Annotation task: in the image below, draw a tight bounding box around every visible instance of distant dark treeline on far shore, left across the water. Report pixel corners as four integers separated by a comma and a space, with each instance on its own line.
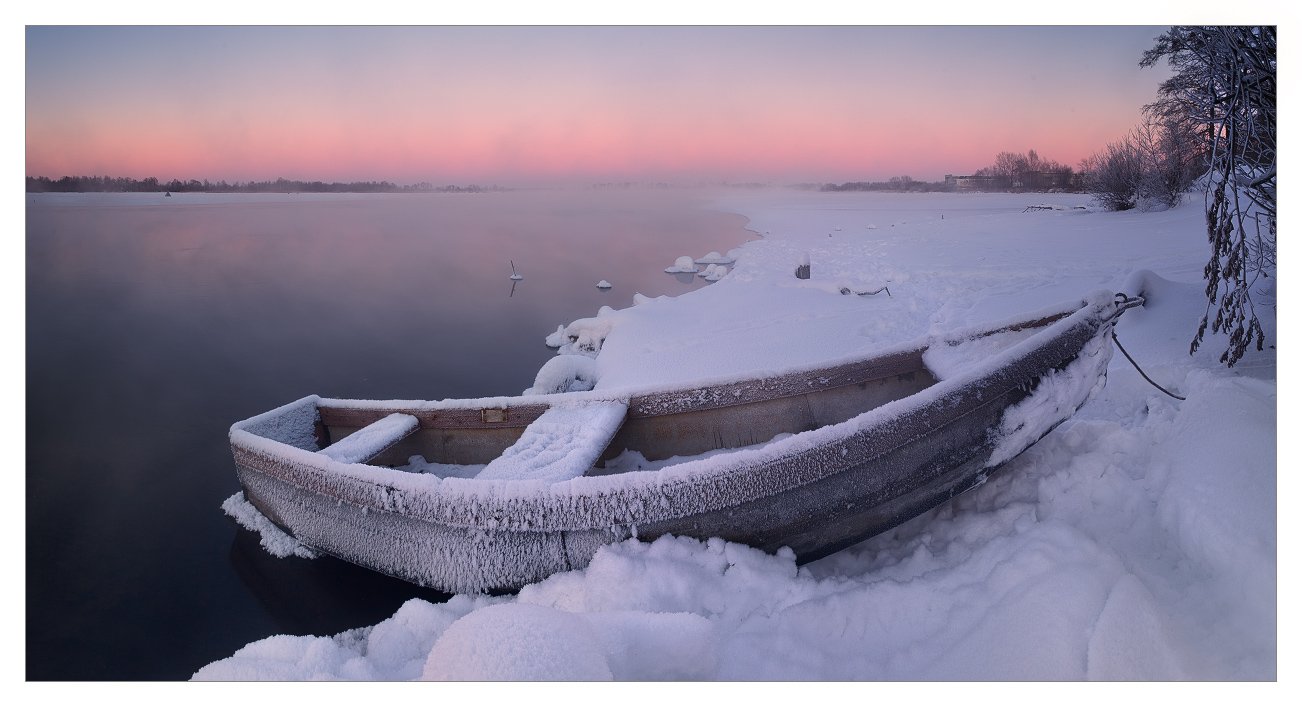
27, 177, 503, 194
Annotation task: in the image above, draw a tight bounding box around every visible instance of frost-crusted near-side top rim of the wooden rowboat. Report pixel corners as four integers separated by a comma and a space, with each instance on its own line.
226, 296, 1112, 531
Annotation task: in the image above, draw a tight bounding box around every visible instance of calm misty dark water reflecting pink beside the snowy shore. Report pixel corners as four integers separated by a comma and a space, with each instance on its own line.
26, 191, 750, 680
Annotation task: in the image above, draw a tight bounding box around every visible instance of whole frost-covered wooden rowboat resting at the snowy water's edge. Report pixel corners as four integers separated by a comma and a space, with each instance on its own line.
230, 294, 1142, 592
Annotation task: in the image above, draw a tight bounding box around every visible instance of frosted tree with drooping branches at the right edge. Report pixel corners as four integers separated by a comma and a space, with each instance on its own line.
1139, 26, 1276, 366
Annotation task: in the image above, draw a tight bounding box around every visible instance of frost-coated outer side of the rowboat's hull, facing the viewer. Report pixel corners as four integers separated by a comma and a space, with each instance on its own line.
232, 295, 1116, 592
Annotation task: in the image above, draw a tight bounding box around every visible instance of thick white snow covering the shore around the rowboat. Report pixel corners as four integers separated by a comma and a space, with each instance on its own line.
195, 191, 1277, 680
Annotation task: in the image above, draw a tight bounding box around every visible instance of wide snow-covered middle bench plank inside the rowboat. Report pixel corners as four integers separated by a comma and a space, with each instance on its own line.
476, 401, 629, 482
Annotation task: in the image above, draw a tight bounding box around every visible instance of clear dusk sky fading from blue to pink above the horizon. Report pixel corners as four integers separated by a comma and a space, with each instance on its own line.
26, 26, 1167, 184
